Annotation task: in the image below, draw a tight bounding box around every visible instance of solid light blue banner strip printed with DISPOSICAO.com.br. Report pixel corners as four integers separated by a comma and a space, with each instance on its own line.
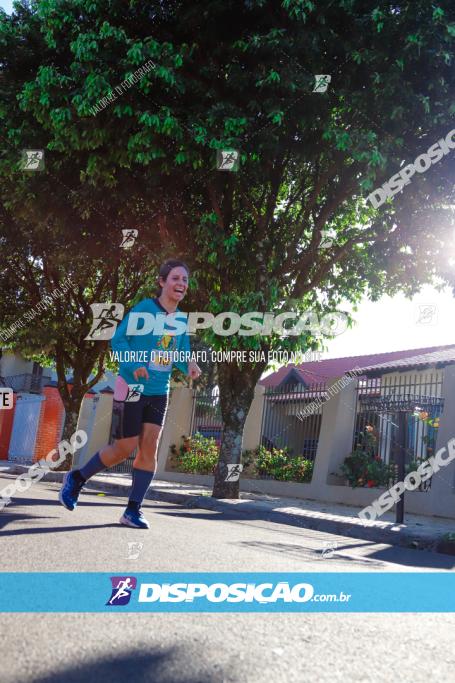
0, 572, 455, 613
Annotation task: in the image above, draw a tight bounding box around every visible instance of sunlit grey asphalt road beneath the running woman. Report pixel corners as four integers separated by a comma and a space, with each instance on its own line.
0, 474, 455, 683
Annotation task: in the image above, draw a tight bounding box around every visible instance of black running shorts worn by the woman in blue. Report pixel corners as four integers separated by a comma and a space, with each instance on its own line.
112, 394, 168, 439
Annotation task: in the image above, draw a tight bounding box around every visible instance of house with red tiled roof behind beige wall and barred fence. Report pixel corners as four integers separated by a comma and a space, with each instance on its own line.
151, 344, 455, 519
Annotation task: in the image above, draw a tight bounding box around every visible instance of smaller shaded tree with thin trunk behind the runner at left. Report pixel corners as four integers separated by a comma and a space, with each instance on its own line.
0, 4, 176, 460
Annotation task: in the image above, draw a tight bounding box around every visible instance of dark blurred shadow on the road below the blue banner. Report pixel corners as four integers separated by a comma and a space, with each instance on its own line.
28, 648, 221, 683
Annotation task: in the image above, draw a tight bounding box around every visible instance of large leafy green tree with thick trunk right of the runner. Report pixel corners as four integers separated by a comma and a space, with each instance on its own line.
2, 0, 455, 497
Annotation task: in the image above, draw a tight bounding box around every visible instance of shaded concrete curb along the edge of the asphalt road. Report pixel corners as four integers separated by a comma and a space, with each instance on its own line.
4, 465, 448, 554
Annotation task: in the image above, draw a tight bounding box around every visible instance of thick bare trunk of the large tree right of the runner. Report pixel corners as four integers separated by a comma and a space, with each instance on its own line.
212, 363, 265, 498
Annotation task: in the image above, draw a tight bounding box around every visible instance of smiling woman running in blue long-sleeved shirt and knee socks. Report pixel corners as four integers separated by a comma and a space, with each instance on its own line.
59, 260, 201, 529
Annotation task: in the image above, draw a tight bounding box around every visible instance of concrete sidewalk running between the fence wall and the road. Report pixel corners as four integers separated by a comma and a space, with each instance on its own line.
1, 465, 455, 555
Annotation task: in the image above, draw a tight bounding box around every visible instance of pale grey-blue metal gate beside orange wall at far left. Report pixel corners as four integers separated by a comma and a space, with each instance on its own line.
8, 394, 45, 463
